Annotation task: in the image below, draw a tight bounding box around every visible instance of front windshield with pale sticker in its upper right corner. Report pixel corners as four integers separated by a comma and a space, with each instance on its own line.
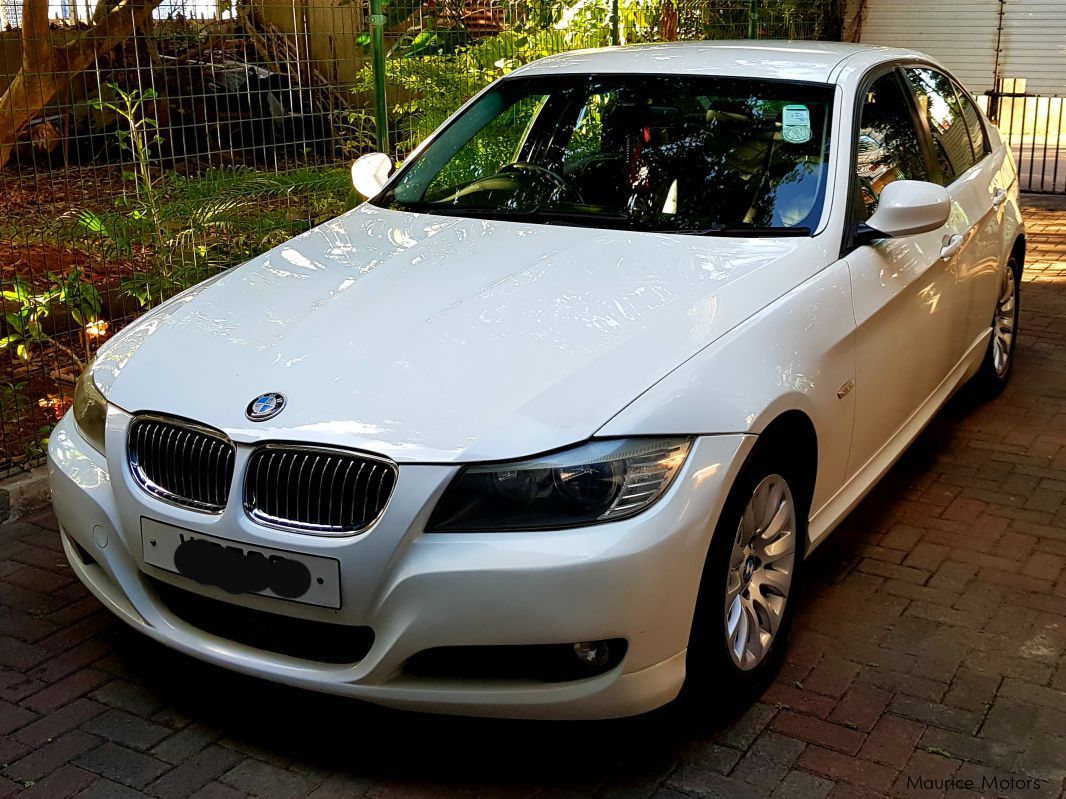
374, 75, 833, 234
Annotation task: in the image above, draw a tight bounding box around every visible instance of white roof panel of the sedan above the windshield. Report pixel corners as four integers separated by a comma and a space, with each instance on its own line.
512, 39, 930, 83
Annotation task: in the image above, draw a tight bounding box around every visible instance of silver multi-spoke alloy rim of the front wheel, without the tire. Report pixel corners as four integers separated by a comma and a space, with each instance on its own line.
725, 474, 796, 671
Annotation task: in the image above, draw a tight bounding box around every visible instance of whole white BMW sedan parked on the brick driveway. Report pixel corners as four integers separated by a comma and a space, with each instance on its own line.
49, 43, 1024, 718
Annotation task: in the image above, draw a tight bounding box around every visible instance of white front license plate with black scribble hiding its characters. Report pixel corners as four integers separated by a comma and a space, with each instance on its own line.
141, 519, 340, 607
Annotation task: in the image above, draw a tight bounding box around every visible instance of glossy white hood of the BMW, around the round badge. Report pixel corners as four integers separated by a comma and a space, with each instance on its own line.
93, 205, 822, 462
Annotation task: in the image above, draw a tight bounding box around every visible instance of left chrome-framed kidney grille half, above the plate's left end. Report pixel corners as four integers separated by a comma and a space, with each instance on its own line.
126, 413, 236, 513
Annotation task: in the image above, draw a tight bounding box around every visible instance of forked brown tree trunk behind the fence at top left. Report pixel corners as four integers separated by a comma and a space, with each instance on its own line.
0, 0, 162, 169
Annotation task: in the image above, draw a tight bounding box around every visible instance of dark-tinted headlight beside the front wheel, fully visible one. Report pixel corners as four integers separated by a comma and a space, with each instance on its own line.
426, 438, 691, 533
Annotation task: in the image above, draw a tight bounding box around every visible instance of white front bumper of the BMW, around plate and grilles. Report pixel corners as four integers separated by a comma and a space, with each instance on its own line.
49, 408, 754, 718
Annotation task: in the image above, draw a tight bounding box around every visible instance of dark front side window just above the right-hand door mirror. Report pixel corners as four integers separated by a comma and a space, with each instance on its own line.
855, 71, 928, 222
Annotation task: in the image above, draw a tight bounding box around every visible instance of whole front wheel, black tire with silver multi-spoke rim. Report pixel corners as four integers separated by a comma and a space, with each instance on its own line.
681, 442, 807, 712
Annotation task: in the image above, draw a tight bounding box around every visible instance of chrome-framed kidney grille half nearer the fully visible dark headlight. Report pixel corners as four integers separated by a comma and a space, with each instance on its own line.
244, 443, 397, 536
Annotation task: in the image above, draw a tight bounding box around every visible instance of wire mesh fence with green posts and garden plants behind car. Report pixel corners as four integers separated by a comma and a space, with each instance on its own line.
0, 0, 843, 476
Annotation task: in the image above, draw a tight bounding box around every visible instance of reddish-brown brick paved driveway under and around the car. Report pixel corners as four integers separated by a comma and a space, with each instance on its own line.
0, 199, 1066, 799
